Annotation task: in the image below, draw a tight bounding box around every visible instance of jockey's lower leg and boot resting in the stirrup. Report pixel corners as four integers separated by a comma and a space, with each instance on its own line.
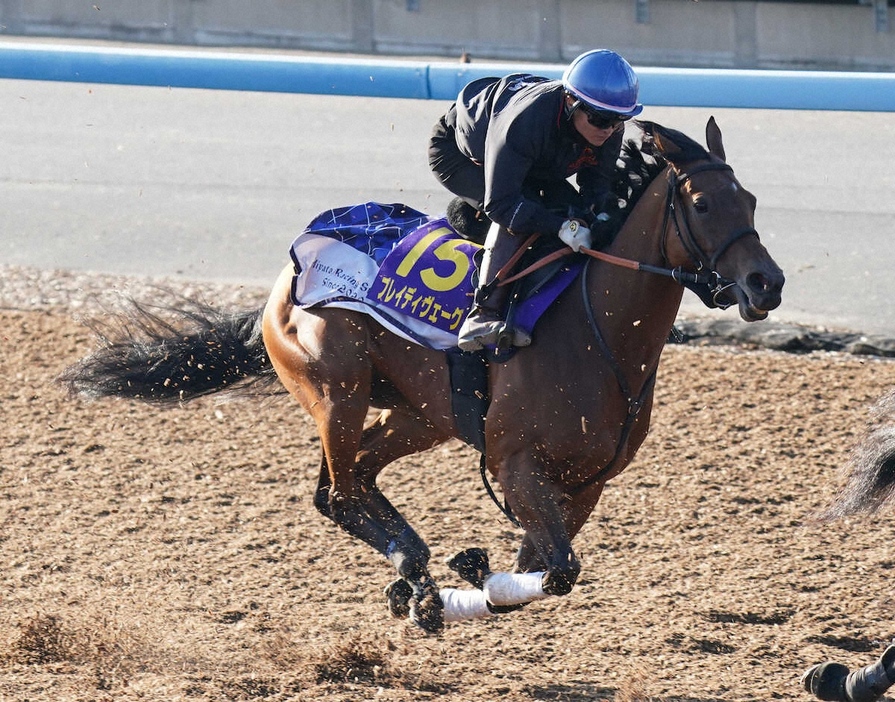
457, 224, 531, 351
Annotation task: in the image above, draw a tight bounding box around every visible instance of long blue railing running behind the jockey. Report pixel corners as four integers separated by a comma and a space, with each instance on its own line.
0, 42, 895, 112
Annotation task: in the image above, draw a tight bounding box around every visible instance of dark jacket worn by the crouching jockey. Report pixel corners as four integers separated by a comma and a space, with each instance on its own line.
445, 73, 624, 234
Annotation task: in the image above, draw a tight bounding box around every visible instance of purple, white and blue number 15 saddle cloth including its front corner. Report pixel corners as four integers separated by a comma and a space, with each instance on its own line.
290, 203, 577, 350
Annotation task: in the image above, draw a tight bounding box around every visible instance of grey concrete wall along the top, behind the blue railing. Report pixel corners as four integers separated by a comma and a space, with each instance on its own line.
0, 0, 895, 71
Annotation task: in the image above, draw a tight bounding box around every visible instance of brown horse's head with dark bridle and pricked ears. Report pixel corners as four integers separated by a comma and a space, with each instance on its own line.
640, 117, 784, 322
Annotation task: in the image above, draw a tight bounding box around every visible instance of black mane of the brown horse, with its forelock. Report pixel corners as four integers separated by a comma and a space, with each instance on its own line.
609, 120, 709, 236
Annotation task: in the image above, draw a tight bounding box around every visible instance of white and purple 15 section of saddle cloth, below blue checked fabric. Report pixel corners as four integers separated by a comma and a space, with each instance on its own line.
291, 219, 481, 350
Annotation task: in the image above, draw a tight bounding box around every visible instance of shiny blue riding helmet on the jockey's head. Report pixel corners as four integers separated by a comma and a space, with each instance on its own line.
562, 49, 643, 117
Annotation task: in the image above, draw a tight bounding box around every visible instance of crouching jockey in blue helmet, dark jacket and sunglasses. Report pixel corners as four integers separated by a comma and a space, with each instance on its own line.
429, 49, 643, 351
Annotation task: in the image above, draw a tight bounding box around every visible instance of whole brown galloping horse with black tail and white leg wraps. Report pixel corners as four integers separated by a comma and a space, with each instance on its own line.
63, 117, 784, 633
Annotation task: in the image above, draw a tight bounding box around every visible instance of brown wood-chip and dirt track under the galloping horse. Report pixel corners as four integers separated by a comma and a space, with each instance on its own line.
0, 270, 895, 702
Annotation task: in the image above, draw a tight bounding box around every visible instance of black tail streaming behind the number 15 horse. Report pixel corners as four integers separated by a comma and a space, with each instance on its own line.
59, 301, 276, 404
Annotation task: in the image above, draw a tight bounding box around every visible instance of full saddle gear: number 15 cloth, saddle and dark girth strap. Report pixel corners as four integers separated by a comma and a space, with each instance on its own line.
290, 202, 583, 451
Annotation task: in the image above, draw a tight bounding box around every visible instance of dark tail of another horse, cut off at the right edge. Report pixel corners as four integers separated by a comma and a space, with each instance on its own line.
821, 391, 895, 520
